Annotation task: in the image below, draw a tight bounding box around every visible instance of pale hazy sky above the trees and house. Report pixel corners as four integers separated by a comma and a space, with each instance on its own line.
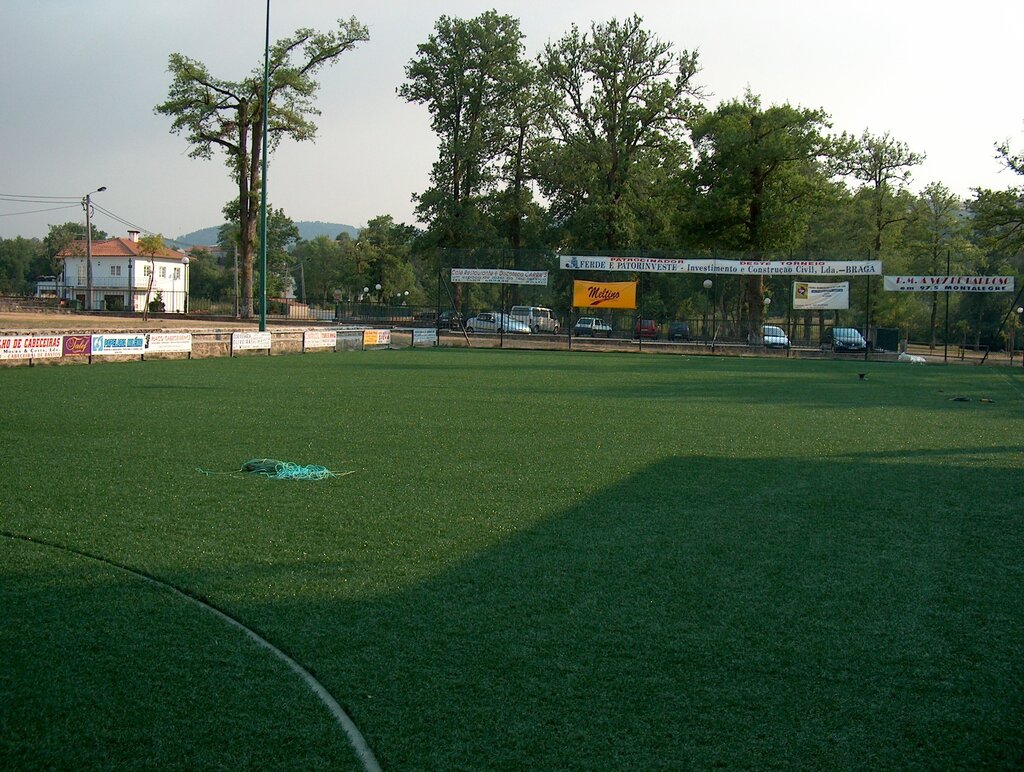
0, 0, 1024, 239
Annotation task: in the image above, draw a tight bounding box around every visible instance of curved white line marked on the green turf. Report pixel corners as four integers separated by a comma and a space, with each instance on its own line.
0, 531, 381, 772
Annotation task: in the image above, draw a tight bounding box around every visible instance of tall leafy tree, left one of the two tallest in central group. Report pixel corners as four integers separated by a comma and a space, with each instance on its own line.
398, 10, 529, 249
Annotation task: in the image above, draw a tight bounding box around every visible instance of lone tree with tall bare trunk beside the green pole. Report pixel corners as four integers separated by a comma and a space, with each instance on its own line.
156, 17, 370, 318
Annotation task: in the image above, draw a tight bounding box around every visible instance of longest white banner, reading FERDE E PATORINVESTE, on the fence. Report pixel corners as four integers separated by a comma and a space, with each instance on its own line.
558, 255, 882, 276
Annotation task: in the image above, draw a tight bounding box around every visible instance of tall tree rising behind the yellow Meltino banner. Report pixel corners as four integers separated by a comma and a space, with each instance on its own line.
536, 15, 699, 249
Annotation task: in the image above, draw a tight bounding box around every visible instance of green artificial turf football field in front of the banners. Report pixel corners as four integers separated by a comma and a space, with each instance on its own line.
0, 349, 1024, 770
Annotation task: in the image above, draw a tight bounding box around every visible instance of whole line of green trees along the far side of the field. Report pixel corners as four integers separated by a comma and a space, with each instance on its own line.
0, 11, 1024, 338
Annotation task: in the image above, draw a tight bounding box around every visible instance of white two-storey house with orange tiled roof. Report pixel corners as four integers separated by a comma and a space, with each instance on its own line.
56, 230, 188, 313
